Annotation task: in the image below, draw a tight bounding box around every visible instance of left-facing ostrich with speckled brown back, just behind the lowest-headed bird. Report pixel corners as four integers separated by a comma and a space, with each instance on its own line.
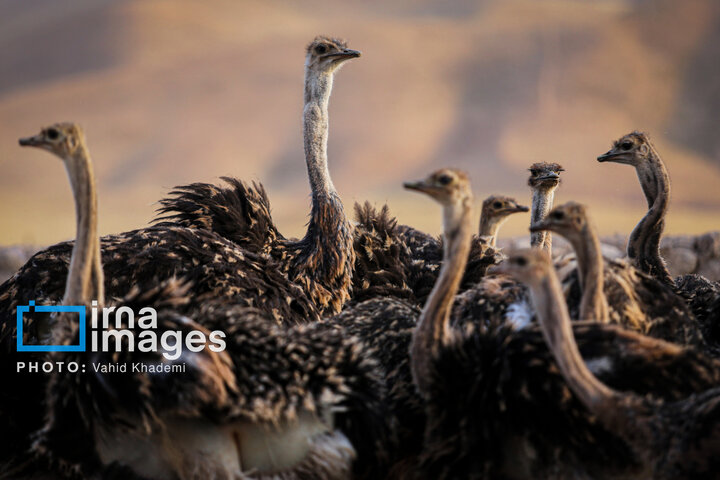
530, 202, 704, 347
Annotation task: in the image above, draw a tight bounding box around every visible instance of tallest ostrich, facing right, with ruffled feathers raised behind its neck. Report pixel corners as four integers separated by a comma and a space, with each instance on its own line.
157, 36, 360, 313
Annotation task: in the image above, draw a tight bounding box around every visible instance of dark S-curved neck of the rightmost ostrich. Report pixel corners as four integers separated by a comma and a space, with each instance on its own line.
627, 151, 675, 286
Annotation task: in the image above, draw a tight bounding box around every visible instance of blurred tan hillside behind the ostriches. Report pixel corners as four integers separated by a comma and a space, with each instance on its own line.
0, 0, 720, 244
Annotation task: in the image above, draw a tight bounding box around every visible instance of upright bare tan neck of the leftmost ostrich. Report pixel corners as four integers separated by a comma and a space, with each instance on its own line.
63, 145, 104, 305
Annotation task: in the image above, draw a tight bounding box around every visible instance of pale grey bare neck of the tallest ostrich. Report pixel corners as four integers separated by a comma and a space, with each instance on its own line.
303, 69, 336, 196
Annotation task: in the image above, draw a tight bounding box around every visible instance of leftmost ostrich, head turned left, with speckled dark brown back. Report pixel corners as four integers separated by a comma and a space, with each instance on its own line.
0, 124, 319, 478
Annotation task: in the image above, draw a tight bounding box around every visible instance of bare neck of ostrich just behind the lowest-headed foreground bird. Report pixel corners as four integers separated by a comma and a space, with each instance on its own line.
568, 222, 610, 323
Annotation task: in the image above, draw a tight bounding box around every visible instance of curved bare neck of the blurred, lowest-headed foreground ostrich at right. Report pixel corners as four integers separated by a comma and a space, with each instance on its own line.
529, 273, 615, 416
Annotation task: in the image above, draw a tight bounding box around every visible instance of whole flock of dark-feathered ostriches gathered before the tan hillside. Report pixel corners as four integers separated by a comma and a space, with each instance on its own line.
0, 37, 720, 479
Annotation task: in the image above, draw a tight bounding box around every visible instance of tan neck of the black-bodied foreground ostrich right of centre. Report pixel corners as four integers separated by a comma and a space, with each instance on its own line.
410, 195, 472, 395
